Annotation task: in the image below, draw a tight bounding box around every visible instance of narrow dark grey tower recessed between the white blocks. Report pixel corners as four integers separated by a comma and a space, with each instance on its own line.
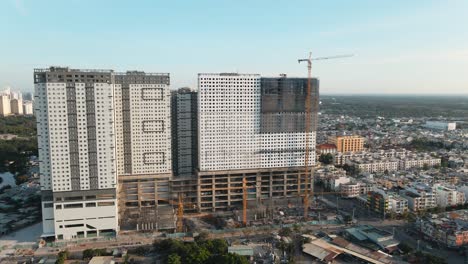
172, 88, 198, 176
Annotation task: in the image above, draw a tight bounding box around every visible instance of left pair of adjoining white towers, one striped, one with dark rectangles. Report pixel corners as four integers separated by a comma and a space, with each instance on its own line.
34, 67, 171, 239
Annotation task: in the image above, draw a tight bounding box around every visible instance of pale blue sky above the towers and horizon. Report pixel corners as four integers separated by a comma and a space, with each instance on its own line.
0, 0, 468, 94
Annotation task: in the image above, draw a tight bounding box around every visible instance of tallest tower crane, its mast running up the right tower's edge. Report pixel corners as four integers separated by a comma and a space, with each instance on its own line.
298, 52, 354, 219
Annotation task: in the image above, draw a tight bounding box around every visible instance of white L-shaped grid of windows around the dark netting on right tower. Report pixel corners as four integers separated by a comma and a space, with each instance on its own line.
198, 74, 315, 171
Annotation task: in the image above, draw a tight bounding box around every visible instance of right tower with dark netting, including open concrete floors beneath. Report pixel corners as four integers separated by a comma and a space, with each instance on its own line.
198, 73, 318, 211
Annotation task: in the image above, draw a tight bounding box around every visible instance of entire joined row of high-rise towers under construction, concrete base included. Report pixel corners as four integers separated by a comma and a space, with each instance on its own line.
34, 67, 318, 239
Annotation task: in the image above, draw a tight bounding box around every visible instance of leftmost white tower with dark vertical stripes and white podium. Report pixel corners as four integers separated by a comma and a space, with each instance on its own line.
34, 67, 118, 239
